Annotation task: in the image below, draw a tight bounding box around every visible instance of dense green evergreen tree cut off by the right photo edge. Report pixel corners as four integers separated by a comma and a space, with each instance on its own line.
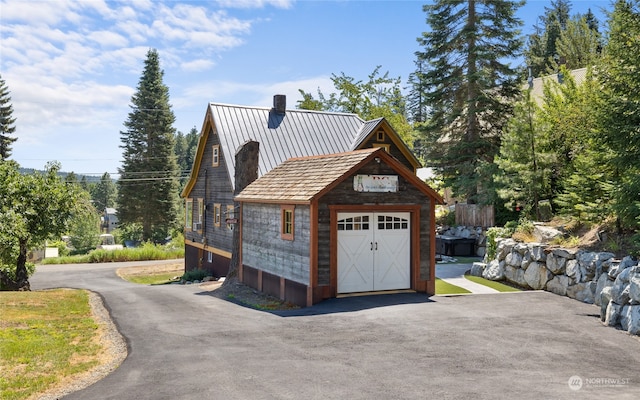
599, 0, 640, 229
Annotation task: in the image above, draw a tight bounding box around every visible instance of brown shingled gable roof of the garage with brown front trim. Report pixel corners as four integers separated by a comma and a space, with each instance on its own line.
235, 148, 443, 204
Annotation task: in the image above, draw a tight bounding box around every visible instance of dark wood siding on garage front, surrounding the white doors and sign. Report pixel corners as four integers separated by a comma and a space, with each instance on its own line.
318, 158, 431, 285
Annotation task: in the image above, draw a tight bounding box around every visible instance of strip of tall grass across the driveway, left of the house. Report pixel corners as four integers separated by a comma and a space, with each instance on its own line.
42, 243, 184, 264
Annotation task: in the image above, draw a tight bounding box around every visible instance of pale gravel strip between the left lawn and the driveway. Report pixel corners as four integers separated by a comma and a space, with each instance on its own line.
33, 291, 128, 400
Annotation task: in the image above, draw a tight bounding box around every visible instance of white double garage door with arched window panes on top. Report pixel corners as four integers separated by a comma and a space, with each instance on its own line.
338, 213, 411, 293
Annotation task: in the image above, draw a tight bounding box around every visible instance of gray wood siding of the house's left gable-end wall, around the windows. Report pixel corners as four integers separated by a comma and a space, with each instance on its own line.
185, 126, 233, 252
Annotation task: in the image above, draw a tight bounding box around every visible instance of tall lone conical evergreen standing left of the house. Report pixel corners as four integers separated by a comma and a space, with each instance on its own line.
118, 49, 178, 241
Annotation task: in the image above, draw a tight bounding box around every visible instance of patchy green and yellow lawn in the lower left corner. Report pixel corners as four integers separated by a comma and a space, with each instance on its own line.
0, 289, 102, 400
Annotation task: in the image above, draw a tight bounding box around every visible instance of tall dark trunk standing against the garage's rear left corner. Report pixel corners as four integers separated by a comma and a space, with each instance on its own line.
223, 141, 260, 286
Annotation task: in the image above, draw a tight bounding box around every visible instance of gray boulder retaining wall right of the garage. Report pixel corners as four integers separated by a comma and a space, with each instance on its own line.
471, 239, 640, 335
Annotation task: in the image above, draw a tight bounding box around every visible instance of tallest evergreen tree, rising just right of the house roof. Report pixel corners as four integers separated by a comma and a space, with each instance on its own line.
417, 0, 523, 203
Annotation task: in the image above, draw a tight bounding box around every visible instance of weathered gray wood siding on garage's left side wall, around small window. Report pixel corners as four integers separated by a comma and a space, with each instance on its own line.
242, 203, 310, 285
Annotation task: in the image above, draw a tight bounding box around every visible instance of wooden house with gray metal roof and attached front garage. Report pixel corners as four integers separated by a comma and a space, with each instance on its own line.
182, 95, 442, 305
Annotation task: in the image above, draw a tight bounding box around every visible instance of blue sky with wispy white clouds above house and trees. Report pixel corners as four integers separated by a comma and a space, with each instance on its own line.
0, 0, 612, 176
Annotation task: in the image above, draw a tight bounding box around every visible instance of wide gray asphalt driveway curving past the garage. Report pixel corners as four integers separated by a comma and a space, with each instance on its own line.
31, 263, 640, 400
